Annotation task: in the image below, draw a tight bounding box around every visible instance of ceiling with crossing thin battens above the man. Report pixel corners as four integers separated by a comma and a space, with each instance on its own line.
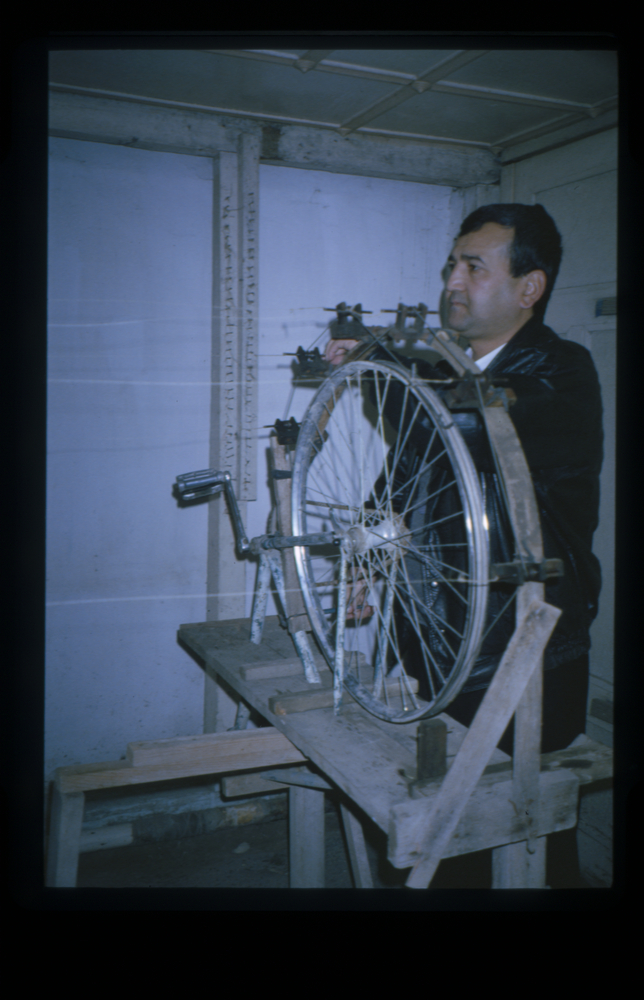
50, 49, 617, 154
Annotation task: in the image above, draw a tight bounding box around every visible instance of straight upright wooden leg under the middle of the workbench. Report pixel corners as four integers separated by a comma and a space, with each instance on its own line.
288, 785, 324, 889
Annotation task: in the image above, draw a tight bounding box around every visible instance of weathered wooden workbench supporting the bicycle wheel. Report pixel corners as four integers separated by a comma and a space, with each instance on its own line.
179, 617, 612, 884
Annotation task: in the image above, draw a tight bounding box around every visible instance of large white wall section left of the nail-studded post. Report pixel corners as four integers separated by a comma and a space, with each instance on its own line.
45, 139, 212, 778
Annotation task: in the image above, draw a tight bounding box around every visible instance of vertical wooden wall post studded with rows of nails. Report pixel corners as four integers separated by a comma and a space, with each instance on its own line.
204, 133, 259, 732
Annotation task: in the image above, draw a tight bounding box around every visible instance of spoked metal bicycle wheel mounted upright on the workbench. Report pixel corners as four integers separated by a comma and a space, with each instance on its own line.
292, 361, 488, 722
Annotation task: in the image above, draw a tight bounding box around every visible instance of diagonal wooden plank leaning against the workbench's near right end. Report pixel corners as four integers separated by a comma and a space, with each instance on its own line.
406, 601, 561, 889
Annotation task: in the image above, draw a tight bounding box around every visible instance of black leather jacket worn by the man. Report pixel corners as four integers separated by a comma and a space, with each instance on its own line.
378, 317, 603, 691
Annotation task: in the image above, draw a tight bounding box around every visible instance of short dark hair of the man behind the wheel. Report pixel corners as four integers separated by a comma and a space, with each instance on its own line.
458, 204, 561, 320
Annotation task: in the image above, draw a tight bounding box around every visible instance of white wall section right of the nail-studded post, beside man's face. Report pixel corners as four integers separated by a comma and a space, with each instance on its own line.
247, 165, 452, 614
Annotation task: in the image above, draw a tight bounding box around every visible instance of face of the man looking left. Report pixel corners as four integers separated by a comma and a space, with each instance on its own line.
445, 222, 532, 340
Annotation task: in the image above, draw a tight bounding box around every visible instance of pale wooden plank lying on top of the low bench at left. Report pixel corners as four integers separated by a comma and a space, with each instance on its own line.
127, 727, 304, 773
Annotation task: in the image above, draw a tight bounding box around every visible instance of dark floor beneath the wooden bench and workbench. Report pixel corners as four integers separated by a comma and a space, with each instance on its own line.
77, 796, 589, 889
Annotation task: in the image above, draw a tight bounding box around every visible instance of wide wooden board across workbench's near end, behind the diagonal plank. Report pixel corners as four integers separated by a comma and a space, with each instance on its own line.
388, 766, 579, 868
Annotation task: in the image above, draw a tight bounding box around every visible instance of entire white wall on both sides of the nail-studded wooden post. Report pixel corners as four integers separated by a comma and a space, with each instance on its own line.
46, 145, 460, 778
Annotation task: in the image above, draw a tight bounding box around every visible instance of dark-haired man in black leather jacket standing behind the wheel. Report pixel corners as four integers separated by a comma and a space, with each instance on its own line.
326, 204, 603, 753
